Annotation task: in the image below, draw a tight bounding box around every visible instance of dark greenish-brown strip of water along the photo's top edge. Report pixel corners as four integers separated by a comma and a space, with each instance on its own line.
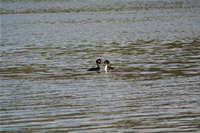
1, 0, 199, 14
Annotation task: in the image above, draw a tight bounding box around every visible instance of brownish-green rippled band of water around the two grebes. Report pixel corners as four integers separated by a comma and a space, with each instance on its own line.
1, 41, 200, 80
